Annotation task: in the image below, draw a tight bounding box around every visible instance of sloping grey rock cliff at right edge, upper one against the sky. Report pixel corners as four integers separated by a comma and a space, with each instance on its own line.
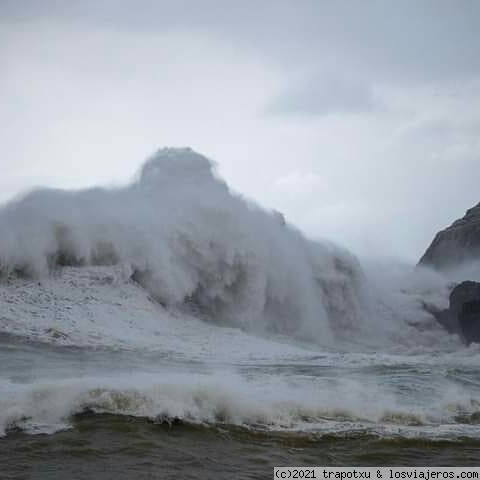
419, 203, 480, 270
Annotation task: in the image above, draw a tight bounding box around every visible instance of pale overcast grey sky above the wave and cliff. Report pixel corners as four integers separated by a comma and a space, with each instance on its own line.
0, 0, 480, 260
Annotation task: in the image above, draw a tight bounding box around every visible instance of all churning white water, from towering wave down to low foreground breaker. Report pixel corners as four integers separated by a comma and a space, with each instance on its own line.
0, 148, 480, 476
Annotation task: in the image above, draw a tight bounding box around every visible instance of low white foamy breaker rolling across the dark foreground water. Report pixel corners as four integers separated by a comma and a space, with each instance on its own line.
0, 372, 480, 436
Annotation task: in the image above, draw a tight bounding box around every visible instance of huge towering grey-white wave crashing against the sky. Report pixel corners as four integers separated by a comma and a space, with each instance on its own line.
0, 148, 464, 344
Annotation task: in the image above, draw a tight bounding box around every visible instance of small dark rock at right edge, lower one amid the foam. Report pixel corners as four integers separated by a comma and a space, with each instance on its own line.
429, 281, 480, 345
